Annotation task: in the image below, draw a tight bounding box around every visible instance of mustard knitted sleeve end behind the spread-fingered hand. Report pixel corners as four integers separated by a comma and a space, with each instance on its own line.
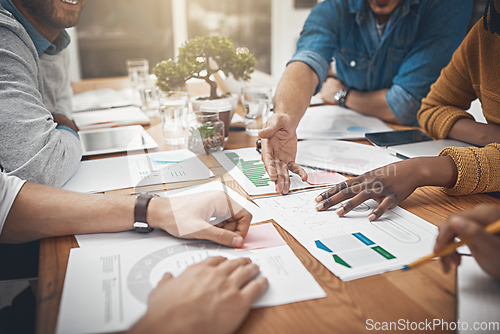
439, 144, 500, 196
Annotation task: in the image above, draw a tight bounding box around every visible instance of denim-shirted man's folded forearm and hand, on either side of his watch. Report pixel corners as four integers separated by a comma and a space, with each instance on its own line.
318, 77, 399, 124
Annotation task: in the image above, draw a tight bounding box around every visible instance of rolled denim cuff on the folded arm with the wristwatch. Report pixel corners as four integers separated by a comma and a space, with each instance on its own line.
385, 85, 420, 126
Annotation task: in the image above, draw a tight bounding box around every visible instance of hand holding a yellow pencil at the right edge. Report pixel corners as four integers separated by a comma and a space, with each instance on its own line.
434, 205, 500, 280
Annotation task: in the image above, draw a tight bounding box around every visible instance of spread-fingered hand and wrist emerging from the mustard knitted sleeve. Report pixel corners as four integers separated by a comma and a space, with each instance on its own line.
316, 156, 457, 220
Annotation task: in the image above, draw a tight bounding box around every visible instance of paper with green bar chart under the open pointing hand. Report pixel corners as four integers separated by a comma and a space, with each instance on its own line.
212, 148, 320, 196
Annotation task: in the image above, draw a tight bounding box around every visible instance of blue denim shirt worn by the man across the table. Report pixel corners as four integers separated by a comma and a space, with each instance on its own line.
290, 0, 472, 125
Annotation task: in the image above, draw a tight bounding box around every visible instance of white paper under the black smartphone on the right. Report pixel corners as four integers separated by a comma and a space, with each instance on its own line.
387, 139, 473, 159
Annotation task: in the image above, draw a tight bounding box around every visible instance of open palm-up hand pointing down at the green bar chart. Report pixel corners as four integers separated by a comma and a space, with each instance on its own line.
259, 114, 307, 194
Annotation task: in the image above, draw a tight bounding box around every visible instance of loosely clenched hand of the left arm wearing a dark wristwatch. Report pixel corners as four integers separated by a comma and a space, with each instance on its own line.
147, 191, 252, 247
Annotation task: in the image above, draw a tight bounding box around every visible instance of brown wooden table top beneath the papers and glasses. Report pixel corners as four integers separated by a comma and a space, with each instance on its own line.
36, 78, 500, 333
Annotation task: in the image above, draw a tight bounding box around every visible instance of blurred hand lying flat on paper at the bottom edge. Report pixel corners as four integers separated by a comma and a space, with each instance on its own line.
130, 257, 268, 334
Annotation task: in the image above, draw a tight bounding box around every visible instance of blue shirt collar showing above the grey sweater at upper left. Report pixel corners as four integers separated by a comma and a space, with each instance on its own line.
0, 0, 71, 55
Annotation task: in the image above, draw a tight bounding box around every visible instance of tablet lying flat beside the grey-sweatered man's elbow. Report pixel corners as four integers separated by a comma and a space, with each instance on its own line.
78, 125, 158, 156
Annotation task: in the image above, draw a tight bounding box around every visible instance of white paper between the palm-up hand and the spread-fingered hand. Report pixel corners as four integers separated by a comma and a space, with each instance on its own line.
295, 140, 401, 175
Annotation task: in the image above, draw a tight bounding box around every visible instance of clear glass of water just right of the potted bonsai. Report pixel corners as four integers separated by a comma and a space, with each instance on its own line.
241, 87, 273, 136
